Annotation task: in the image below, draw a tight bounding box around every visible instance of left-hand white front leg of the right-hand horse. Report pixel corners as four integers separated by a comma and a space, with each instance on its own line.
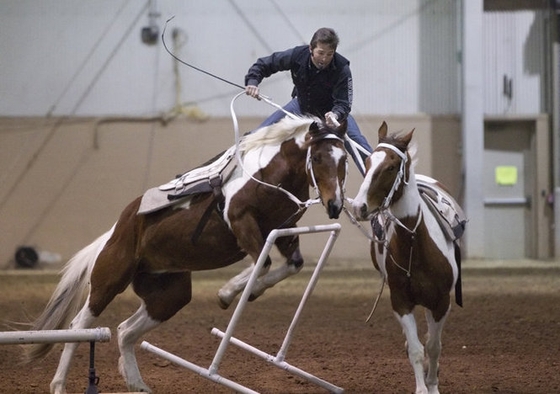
395, 311, 428, 394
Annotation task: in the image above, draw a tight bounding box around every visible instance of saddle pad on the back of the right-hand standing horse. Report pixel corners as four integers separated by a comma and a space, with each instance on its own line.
416, 175, 467, 241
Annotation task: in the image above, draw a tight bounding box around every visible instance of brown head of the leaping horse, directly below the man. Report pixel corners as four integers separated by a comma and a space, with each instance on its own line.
306, 121, 348, 219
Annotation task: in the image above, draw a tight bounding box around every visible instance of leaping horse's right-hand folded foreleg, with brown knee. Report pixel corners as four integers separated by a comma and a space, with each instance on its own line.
249, 236, 303, 301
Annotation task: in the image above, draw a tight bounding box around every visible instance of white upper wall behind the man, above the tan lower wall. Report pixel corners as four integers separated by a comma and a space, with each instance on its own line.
0, 0, 459, 116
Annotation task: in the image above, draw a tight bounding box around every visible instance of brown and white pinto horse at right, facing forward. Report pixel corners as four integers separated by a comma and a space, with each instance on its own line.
352, 122, 464, 394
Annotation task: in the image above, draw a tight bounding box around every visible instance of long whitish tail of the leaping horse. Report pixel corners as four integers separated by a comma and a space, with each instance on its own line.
25, 227, 114, 362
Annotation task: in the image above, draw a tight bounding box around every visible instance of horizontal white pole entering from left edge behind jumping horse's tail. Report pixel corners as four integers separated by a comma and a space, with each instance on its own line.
0, 327, 111, 345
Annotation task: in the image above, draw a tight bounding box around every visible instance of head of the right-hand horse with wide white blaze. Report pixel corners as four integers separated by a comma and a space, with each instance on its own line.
352, 122, 414, 220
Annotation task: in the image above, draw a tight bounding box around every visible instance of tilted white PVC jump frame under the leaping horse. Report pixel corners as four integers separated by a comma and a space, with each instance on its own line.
140, 223, 344, 394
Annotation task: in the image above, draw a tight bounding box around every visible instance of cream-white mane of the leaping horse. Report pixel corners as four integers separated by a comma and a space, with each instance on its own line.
239, 116, 316, 152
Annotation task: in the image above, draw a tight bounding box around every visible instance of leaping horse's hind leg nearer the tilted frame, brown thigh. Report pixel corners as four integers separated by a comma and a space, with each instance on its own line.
118, 272, 192, 393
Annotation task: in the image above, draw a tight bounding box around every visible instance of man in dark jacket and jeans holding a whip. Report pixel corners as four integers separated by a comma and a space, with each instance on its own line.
245, 27, 372, 175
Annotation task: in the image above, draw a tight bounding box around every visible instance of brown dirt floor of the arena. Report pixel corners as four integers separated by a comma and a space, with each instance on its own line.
0, 261, 560, 394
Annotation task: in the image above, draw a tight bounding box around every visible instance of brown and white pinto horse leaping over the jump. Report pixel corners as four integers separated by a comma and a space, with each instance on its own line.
27, 117, 347, 394
